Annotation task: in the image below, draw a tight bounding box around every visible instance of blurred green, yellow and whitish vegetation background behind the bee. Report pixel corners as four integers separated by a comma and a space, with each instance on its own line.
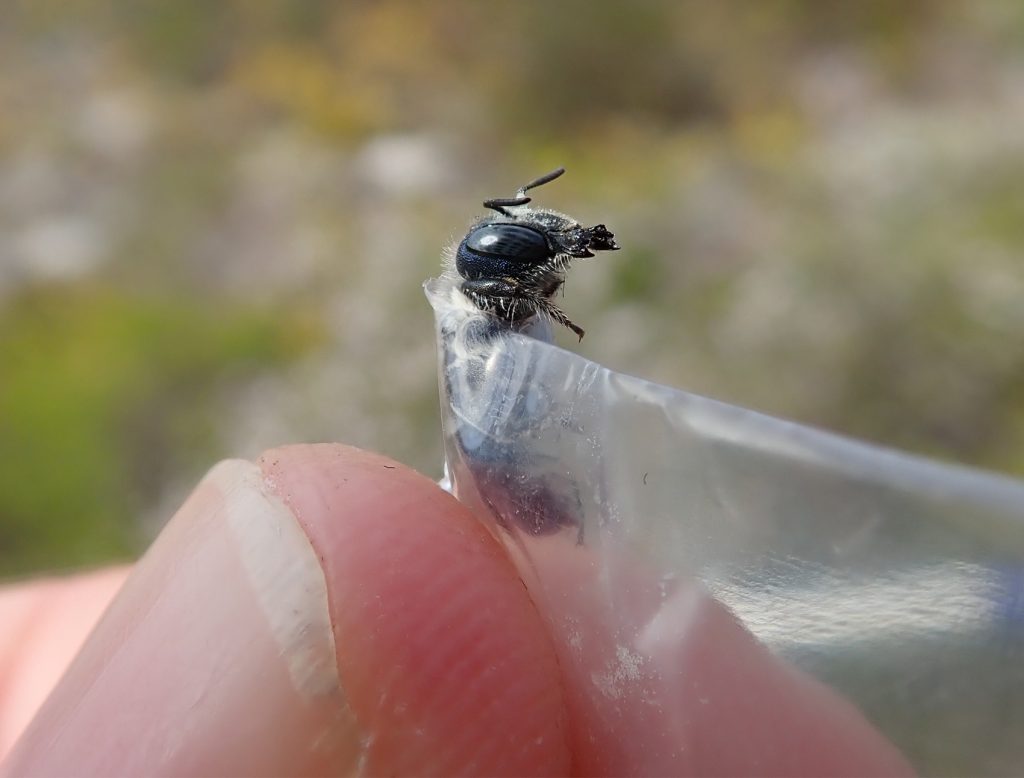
0, 0, 1024, 577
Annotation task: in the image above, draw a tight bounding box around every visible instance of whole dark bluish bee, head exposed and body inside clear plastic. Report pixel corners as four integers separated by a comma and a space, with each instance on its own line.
435, 168, 618, 543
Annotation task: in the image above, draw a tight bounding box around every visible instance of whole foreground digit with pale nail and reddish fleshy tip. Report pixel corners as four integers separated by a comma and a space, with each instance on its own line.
5, 446, 568, 775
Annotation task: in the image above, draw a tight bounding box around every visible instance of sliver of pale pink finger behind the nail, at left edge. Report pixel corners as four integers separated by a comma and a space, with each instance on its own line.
0, 567, 128, 759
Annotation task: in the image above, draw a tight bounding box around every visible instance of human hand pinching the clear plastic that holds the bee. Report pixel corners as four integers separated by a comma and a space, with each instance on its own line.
0, 445, 909, 775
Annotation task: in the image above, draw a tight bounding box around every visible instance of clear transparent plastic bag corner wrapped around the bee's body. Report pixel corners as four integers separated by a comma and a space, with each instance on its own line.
427, 280, 1024, 775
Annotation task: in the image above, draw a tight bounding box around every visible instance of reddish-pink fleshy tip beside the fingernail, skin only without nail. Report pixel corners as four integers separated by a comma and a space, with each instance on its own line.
259, 445, 569, 775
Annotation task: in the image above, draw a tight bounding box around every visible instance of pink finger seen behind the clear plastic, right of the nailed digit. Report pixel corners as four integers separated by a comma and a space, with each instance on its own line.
521, 537, 912, 776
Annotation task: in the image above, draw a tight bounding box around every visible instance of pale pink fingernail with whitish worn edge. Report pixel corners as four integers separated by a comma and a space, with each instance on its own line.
6, 461, 359, 775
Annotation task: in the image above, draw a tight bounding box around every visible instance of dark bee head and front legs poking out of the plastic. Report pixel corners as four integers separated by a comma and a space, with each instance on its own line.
455, 168, 620, 340
